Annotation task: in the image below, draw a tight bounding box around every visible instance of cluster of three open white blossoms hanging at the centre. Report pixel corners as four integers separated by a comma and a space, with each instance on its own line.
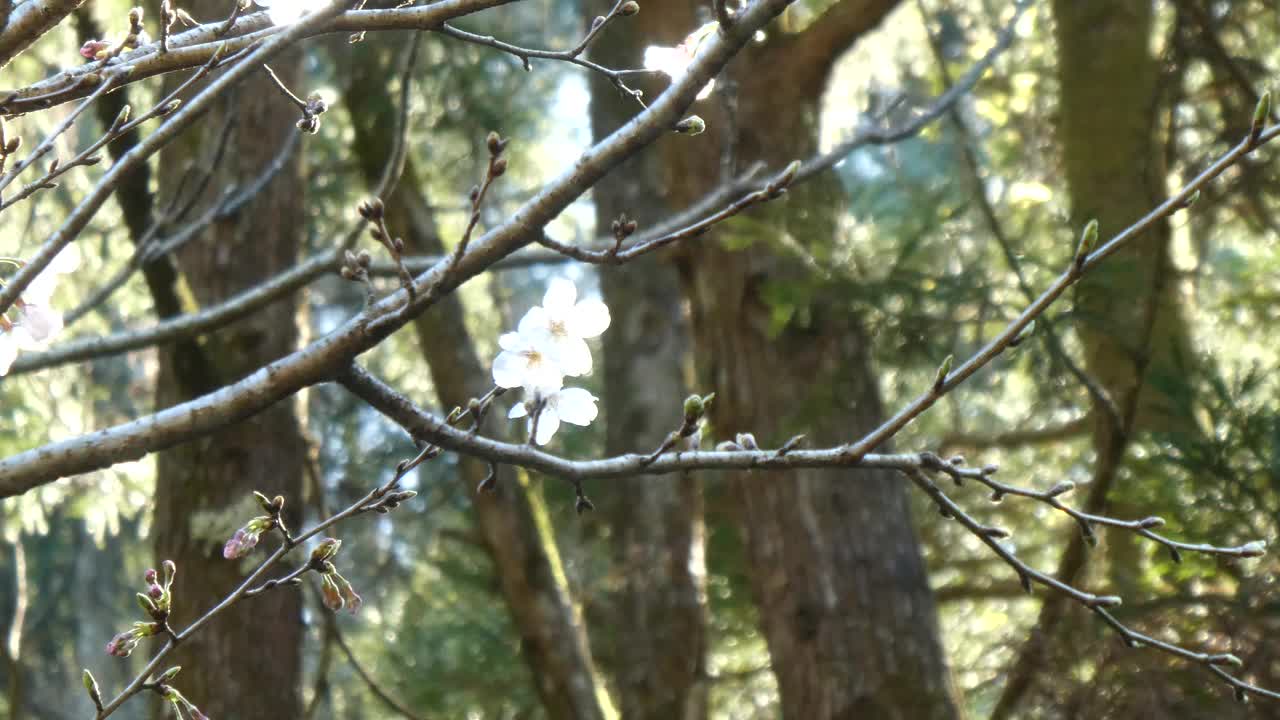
493, 278, 609, 445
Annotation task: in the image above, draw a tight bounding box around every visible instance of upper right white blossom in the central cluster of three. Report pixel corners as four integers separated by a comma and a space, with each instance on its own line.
518, 278, 609, 376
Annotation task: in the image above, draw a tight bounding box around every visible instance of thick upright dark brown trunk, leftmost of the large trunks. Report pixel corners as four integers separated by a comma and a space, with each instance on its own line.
155, 19, 306, 717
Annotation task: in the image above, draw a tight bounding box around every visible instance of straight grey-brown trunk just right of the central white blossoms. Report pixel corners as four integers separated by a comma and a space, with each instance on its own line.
588, 11, 708, 720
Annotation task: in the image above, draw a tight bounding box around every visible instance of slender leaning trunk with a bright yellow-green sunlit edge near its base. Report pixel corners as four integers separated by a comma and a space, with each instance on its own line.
344, 40, 613, 720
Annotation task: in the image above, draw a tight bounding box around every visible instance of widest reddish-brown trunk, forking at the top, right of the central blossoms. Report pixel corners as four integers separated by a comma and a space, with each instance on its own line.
637, 0, 959, 719
